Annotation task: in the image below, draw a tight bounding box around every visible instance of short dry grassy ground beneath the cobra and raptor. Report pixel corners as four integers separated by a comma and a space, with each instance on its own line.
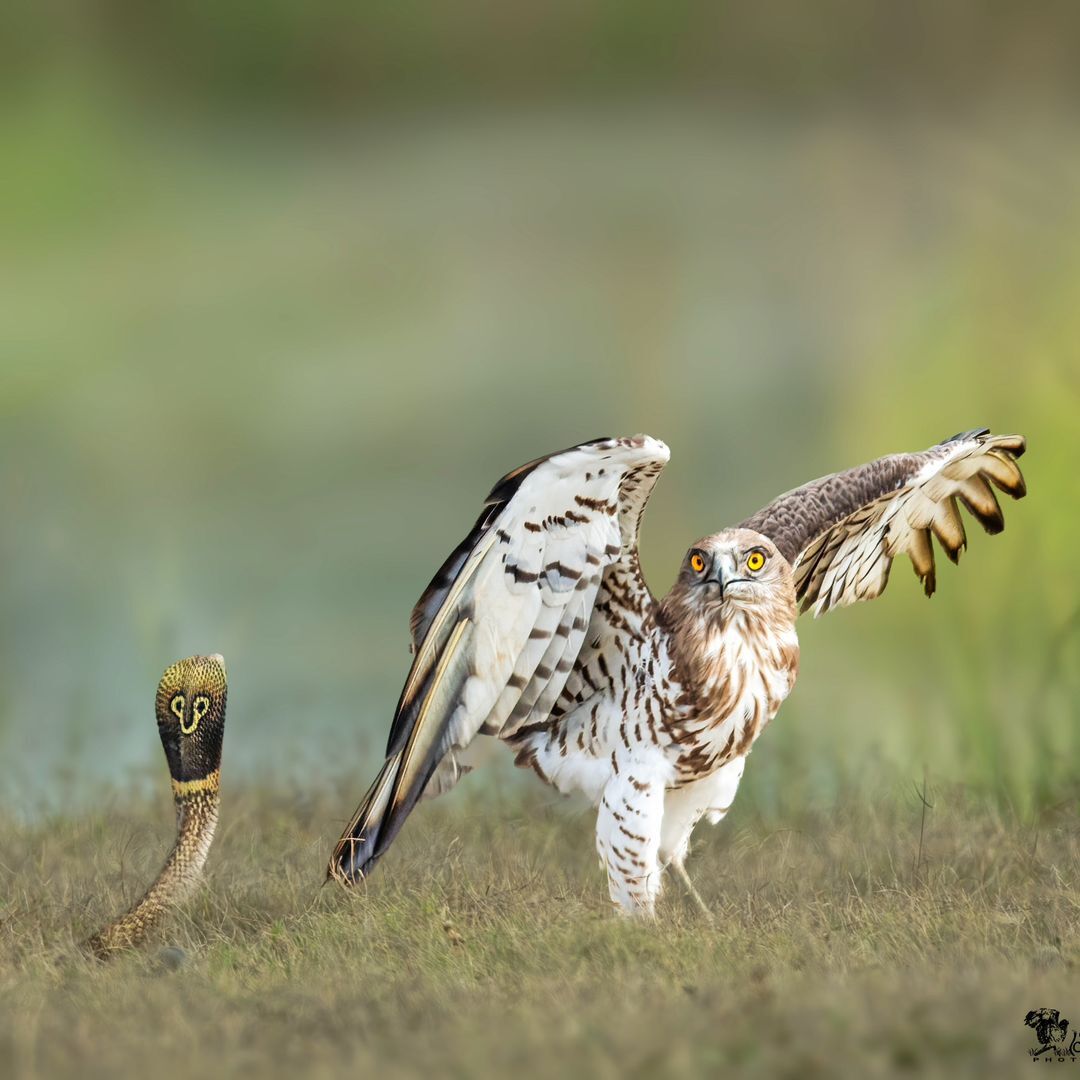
0, 789, 1080, 1077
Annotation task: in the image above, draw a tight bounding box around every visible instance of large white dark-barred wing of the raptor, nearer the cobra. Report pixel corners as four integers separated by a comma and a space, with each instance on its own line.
329, 435, 669, 880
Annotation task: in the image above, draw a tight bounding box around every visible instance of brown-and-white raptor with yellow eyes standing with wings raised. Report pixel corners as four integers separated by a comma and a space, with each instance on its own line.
328, 429, 1025, 916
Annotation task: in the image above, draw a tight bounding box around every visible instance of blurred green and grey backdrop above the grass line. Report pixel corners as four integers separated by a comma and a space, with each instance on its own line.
0, 0, 1080, 816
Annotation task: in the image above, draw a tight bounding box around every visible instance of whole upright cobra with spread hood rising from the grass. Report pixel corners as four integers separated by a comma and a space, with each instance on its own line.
86, 656, 228, 958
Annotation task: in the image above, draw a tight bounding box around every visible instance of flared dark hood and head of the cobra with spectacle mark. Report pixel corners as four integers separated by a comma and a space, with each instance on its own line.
154, 654, 228, 793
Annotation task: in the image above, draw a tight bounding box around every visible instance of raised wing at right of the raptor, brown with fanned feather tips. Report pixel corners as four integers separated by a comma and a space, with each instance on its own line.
742, 429, 1026, 616
